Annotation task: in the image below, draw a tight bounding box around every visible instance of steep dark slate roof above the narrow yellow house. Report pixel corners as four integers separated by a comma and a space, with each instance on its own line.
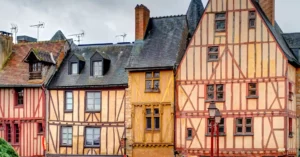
127, 15, 188, 69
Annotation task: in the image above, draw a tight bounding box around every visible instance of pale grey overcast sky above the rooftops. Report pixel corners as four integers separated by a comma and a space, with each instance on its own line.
0, 0, 300, 43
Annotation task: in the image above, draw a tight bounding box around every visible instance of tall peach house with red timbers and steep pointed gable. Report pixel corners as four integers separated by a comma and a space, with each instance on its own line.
175, 0, 299, 157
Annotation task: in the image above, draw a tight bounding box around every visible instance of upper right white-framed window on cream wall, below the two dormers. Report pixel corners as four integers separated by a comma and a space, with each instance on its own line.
86, 92, 101, 111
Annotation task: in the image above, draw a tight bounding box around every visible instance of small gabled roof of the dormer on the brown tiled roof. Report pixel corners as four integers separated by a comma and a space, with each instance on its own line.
24, 48, 56, 64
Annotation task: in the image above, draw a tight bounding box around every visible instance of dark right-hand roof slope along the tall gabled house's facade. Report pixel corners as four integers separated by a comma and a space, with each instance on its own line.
252, 0, 300, 66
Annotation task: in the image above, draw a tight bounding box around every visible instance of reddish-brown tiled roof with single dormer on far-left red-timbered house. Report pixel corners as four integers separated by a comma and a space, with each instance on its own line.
0, 41, 66, 87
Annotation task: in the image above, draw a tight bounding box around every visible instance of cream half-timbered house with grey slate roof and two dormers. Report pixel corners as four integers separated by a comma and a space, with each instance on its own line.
47, 43, 132, 157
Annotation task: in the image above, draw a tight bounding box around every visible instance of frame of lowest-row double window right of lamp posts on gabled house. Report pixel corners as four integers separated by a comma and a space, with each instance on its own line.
235, 117, 254, 136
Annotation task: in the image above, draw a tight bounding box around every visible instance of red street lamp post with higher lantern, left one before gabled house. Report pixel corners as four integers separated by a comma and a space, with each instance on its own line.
208, 102, 217, 157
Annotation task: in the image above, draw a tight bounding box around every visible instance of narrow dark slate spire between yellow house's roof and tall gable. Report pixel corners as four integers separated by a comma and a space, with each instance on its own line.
186, 0, 204, 35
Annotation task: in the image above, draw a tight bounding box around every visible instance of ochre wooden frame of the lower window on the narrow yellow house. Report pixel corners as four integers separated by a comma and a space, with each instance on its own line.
144, 107, 162, 131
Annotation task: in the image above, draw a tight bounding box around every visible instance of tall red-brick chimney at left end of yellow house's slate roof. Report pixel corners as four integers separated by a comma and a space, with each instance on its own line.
135, 4, 150, 40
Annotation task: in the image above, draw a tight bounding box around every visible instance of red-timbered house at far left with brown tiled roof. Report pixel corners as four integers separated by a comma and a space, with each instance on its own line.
0, 32, 69, 157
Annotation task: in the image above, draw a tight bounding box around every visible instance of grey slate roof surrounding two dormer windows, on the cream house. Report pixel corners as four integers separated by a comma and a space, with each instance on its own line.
48, 44, 133, 89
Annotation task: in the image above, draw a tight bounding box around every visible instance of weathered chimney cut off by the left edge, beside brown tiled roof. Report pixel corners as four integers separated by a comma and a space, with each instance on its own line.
0, 31, 13, 69
